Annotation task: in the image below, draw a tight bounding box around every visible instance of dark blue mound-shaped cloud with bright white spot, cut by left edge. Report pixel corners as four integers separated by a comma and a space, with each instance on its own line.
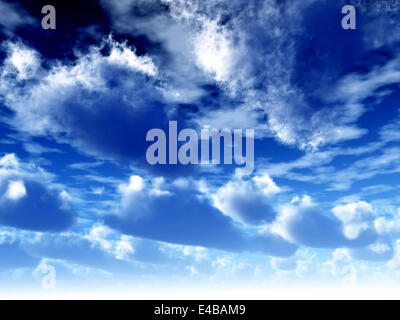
0, 154, 75, 232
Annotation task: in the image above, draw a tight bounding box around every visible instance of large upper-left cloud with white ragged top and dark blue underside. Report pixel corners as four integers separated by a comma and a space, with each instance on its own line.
0, 38, 185, 172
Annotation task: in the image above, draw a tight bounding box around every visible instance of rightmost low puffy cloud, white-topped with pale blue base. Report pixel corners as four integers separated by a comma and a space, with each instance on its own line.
267, 196, 377, 248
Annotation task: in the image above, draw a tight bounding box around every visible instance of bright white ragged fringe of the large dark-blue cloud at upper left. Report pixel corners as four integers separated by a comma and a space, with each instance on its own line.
0, 37, 158, 136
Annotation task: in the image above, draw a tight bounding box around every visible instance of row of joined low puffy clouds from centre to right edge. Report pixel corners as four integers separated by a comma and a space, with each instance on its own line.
105, 171, 400, 262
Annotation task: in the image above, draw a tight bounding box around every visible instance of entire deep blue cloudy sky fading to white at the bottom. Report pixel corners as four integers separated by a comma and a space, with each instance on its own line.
0, 0, 400, 294
